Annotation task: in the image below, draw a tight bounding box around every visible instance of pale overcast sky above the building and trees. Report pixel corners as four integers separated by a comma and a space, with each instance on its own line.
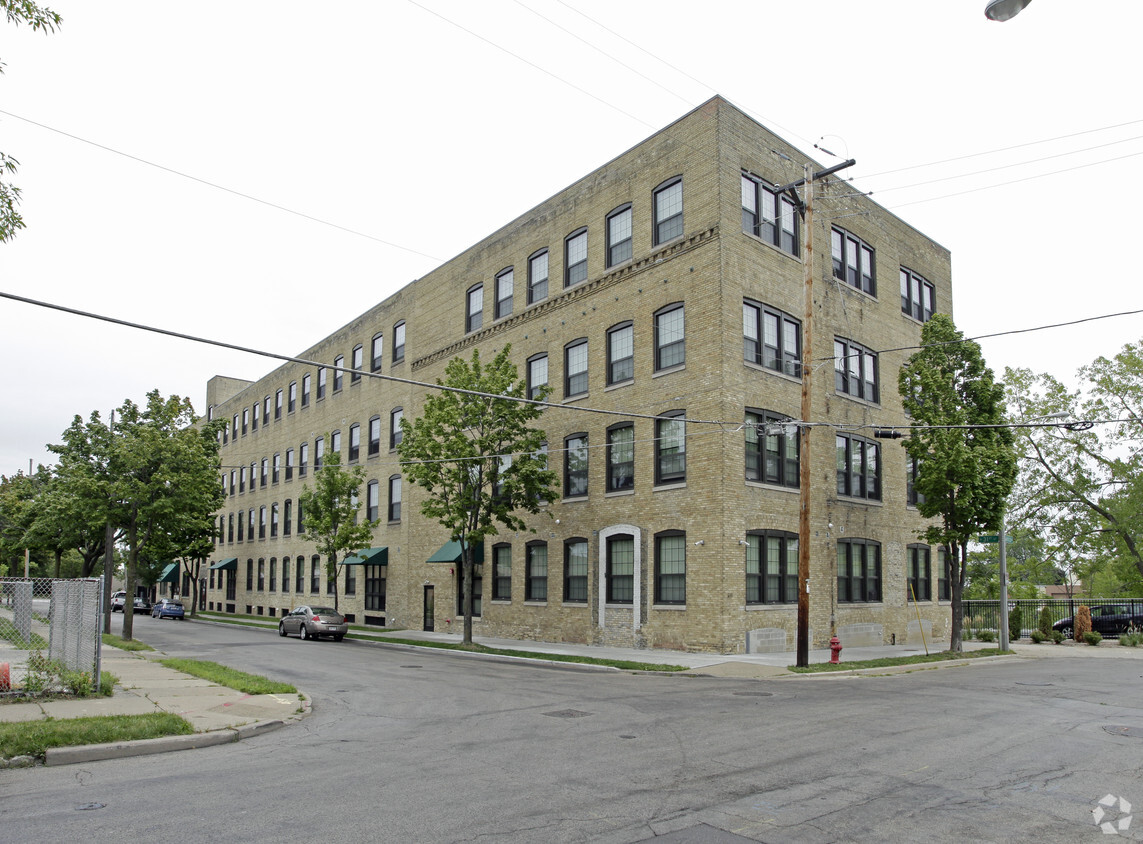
0, 0, 1143, 475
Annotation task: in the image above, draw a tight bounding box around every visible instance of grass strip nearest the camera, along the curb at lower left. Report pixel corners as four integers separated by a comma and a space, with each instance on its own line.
0, 712, 194, 758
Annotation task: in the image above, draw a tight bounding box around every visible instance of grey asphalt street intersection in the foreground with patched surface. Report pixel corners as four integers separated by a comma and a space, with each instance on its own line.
0, 618, 1143, 844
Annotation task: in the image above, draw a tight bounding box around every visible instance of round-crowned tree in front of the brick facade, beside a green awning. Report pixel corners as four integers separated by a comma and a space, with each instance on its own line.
398, 345, 557, 644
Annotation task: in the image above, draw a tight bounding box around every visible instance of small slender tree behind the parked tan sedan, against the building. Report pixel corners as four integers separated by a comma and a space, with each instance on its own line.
297, 448, 377, 610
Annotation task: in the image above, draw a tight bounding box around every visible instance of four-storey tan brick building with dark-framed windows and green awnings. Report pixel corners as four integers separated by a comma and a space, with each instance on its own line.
207, 97, 952, 653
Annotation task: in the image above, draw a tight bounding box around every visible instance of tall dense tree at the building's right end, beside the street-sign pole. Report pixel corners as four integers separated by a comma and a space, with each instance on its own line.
898, 313, 1016, 651
